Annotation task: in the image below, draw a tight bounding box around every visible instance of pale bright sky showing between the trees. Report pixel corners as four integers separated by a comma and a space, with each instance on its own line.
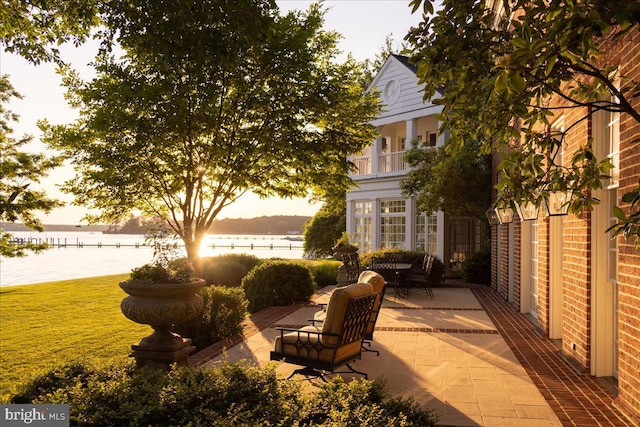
0, 0, 420, 224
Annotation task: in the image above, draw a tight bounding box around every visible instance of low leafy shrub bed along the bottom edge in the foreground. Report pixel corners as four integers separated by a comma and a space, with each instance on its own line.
13, 364, 438, 427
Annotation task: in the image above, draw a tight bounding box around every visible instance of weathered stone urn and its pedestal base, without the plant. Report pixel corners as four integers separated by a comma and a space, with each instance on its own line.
120, 279, 205, 370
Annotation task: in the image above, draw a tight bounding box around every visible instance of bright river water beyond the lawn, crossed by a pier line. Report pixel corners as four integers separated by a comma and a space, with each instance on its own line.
0, 232, 303, 286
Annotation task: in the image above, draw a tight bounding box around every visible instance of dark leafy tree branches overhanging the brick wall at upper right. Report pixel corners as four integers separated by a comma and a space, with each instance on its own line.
407, 0, 640, 244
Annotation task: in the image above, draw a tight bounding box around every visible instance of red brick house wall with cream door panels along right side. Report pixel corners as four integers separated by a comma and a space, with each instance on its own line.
489, 1, 640, 421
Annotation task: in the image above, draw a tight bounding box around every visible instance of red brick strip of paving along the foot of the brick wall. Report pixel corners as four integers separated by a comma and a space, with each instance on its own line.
472, 288, 636, 427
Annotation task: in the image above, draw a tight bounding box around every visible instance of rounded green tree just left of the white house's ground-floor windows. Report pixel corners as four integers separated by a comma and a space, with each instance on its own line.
304, 197, 347, 258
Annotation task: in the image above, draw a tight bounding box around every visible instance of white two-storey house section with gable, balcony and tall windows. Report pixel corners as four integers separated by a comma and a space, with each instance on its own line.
346, 55, 483, 271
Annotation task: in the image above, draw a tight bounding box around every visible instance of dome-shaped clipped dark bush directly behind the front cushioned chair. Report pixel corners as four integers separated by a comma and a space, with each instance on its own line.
242, 261, 315, 313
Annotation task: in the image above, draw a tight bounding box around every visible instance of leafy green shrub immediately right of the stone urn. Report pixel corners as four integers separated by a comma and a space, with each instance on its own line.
175, 286, 248, 350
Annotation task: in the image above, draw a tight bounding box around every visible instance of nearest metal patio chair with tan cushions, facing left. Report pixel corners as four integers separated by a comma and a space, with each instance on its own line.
270, 283, 376, 381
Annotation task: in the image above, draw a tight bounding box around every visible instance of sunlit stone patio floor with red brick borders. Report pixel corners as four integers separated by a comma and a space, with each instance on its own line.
193, 287, 633, 427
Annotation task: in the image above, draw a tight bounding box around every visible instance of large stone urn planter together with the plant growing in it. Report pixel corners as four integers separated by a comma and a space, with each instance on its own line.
120, 234, 206, 369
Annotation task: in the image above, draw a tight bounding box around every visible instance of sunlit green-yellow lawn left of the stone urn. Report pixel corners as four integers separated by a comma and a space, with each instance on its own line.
0, 274, 146, 402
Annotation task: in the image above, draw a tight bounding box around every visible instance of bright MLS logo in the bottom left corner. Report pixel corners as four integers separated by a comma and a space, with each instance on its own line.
0, 405, 69, 427
